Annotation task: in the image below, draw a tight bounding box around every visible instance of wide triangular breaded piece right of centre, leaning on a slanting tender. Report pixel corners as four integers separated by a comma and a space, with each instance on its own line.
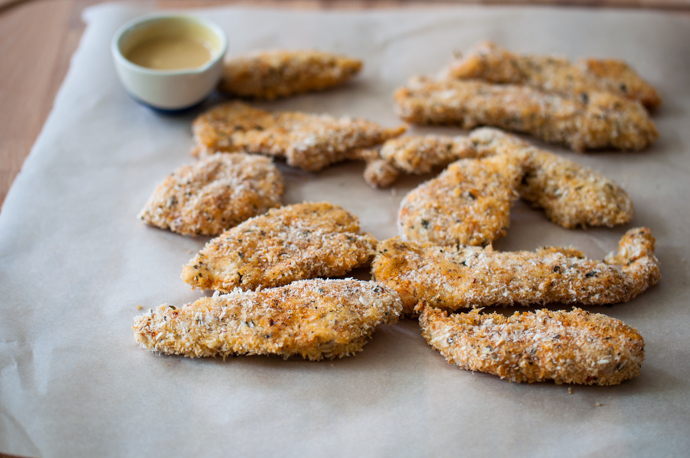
398, 154, 522, 246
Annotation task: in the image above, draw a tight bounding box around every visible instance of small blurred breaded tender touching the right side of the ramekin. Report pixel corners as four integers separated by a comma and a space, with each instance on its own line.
218, 50, 362, 100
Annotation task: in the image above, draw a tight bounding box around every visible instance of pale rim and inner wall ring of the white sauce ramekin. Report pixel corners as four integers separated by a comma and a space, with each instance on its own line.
110, 13, 228, 75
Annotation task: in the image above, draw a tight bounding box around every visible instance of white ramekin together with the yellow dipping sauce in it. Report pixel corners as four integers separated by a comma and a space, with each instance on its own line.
111, 14, 228, 112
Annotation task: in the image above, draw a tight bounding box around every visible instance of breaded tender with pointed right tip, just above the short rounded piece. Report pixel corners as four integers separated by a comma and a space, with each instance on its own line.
192, 102, 405, 172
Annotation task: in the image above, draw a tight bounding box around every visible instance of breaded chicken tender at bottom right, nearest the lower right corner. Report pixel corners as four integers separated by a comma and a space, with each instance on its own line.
419, 306, 644, 385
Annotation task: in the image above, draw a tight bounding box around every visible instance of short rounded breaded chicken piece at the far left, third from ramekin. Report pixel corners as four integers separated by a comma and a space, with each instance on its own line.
139, 153, 283, 235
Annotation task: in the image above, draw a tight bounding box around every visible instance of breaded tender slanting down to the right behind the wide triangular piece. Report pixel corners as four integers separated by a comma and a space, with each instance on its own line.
470, 128, 634, 229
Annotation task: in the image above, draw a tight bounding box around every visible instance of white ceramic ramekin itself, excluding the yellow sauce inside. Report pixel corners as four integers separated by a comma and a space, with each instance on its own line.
111, 14, 228, 112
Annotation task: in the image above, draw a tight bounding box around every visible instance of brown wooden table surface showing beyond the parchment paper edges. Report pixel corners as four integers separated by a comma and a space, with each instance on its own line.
0, 0, 690, 214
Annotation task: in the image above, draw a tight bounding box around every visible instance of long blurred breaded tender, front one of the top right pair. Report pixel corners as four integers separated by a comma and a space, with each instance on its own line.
394, 78, 658, 151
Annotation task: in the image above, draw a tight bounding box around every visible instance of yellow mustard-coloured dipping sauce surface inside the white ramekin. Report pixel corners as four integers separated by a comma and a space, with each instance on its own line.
125, 37, 213, 70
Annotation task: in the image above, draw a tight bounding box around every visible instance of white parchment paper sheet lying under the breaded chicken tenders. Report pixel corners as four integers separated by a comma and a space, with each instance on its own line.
0, 5, 690, 457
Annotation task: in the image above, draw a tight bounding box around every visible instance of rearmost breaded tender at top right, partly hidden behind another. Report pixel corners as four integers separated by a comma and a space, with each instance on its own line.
441, 41, 661, 110
